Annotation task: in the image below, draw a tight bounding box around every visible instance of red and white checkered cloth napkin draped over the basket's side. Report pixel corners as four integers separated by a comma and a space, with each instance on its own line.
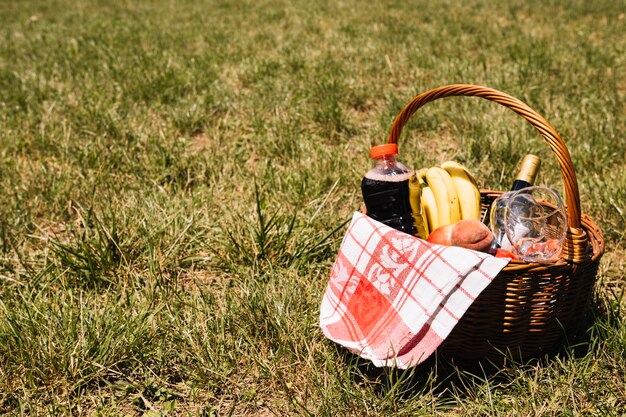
320, 212, 509, 369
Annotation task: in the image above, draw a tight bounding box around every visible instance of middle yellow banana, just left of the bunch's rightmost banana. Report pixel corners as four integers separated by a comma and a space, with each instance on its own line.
426, 167, 461, 230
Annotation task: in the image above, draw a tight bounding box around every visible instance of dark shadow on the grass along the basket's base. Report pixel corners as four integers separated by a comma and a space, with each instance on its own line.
339, 290, 623, 404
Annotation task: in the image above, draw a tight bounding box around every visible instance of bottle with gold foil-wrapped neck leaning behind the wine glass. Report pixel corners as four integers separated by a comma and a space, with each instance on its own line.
490, 154, 541, 250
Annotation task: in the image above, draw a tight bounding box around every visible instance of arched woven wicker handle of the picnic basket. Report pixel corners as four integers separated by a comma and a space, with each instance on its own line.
388, 84, 584, 229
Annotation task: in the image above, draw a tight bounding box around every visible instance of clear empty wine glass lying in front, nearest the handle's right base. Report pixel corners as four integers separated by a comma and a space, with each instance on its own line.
504, 186, 567, 262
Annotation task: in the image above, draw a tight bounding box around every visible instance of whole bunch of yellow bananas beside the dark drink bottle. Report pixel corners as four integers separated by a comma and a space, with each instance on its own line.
409, 161, 480, 239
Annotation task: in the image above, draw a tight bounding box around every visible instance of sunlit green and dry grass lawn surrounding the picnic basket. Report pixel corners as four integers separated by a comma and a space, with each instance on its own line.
0, 0, 626, 416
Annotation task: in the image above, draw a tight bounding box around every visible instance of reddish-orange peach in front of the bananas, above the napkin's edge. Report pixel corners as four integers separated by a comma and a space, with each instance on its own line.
427, 219, 493, 252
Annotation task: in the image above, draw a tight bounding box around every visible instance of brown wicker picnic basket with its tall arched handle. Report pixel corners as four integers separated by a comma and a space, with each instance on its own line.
388, 84, 604, 360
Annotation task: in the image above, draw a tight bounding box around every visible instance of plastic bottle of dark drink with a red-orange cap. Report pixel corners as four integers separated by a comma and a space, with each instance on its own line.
361, 143, 417, 235
